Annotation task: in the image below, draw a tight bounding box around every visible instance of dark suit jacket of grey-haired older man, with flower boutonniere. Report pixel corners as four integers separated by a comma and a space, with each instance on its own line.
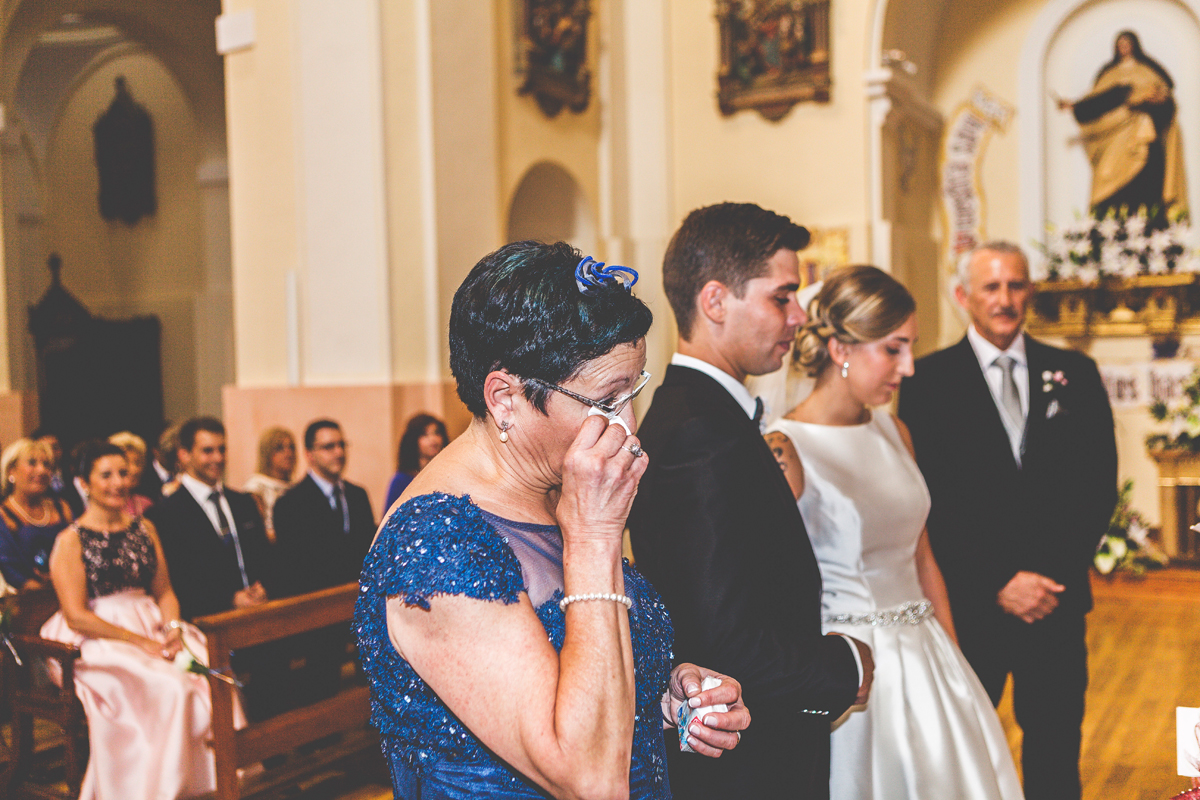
899, 336, 1117, 628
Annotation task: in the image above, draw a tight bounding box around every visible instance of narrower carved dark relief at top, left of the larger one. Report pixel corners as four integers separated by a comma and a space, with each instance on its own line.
517, 0, 592, 118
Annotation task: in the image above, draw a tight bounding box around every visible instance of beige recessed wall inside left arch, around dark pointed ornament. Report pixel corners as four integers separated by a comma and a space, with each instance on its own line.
44, 53, 207, 417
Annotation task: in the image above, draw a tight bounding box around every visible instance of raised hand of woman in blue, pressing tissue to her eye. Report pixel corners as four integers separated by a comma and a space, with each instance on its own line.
556, 416, 649, 542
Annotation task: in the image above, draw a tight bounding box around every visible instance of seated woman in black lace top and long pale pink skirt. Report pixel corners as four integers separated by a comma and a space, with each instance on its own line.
42, 441, 240, 800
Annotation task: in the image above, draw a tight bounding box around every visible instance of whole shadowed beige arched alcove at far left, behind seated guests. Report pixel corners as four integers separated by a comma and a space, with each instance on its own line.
0, 0, 234, 419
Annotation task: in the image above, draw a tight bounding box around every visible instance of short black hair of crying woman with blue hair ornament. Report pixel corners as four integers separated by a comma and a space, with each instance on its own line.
450, 241, 654, 419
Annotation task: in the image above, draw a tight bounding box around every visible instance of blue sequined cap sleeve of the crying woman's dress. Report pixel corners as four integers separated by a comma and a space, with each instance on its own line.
362, 493, 524, 609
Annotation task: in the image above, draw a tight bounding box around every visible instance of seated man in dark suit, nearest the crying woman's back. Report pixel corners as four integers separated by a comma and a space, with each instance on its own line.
274, 420, 376, 704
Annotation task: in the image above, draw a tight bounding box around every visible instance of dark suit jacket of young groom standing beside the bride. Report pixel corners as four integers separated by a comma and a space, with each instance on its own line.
629, 366, 858, 800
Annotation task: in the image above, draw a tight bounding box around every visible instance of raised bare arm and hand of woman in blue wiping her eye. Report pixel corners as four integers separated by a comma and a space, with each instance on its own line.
386, 417, 647, 798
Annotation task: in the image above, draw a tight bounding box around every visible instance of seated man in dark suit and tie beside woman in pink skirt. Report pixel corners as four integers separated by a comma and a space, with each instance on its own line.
146, 416, 276, 718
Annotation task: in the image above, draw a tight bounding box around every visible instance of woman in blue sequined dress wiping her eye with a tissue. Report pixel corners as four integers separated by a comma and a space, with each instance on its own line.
355, 242, 750, 800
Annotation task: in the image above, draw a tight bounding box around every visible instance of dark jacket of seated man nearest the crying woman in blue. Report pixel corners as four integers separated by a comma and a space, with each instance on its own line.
272, 475, 376, 596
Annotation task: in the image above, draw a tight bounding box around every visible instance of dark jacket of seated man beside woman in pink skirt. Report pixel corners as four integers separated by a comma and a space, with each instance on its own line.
146, 486, 275, 620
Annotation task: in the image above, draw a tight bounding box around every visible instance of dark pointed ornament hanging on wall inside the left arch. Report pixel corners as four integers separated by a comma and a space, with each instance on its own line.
92, 76, 158, 225
